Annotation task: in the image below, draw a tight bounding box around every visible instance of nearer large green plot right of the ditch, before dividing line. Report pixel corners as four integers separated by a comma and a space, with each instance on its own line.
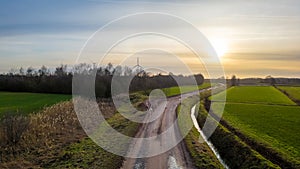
213, 103, 300, 160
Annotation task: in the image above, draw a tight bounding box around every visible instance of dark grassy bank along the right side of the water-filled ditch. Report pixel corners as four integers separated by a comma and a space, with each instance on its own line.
197, 101, 279, 169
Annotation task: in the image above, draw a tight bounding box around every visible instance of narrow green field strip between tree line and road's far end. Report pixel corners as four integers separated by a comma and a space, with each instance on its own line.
163, 83, 210, 97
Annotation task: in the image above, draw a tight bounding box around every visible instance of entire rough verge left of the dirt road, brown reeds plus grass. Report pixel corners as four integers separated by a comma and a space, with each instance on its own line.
0, 94, 145, 169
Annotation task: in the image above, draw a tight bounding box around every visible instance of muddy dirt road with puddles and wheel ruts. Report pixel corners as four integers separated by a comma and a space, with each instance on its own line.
122, 91, 199, 169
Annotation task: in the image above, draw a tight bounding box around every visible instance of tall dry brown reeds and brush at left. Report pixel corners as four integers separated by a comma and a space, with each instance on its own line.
0, 101, 115, 168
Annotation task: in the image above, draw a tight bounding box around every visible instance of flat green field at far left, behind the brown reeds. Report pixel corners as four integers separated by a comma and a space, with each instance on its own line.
0, 92, 72, 116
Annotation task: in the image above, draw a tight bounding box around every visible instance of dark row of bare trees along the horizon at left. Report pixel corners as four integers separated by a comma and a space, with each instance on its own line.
0, 63, 204, 98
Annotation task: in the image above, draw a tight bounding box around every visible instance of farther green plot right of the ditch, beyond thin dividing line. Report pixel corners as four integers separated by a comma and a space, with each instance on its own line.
212, 86, 296, 105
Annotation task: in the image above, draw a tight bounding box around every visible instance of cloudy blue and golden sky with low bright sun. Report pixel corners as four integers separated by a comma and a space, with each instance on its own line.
0, 0, 300, 78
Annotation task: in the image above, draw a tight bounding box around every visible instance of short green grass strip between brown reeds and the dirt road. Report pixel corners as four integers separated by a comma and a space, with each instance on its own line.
44, 93, 147, 169
